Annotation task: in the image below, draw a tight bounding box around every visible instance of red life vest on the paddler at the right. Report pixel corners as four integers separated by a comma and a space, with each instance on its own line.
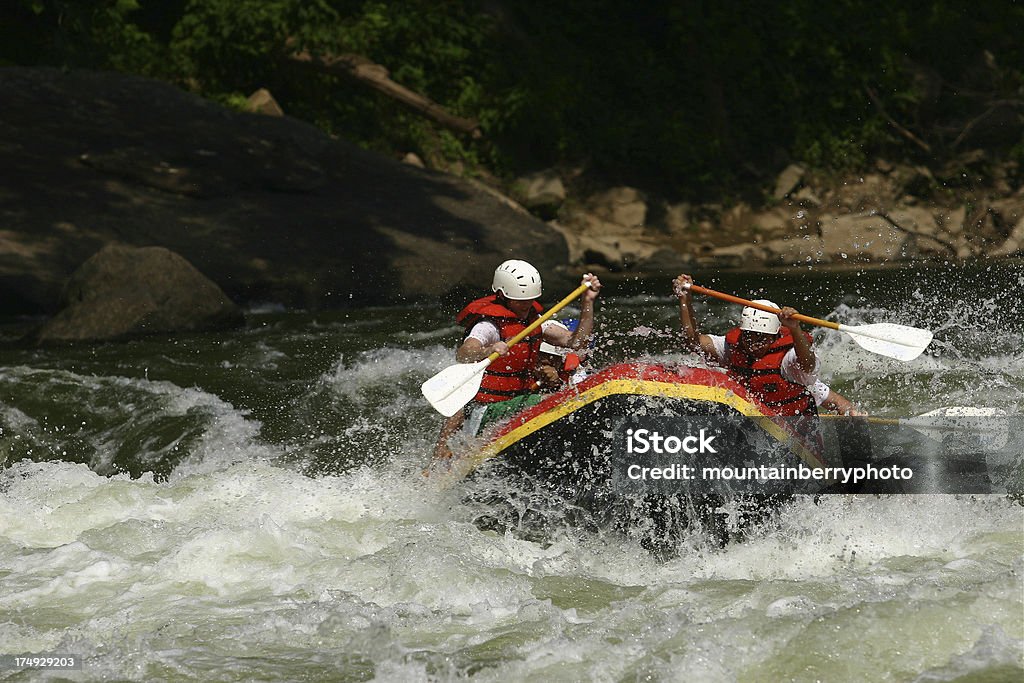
725, 328, 818, 416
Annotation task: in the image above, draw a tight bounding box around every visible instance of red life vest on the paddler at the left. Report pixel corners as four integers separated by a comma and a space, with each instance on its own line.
455, 294, 544, 403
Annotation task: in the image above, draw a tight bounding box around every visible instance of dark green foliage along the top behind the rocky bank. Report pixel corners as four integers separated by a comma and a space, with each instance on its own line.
0, 0, 1024, 196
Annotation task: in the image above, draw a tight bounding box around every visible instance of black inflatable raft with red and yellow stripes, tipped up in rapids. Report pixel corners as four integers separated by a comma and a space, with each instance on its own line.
454, 364, 864, 547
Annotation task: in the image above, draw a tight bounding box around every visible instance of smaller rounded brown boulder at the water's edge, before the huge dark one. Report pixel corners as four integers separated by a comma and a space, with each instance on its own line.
34, 245, 245, 345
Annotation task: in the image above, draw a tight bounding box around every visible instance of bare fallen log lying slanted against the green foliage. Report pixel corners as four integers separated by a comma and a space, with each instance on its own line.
288, 50, 482, 139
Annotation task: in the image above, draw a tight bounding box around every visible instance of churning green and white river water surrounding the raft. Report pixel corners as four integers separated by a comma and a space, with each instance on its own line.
0, 264, 1024, 682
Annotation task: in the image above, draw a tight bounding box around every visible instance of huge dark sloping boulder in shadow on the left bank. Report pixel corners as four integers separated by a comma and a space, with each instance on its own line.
0, 68, 577, 313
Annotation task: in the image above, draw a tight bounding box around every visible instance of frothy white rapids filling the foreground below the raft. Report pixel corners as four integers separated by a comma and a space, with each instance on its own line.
0, 454, 1024, 681
